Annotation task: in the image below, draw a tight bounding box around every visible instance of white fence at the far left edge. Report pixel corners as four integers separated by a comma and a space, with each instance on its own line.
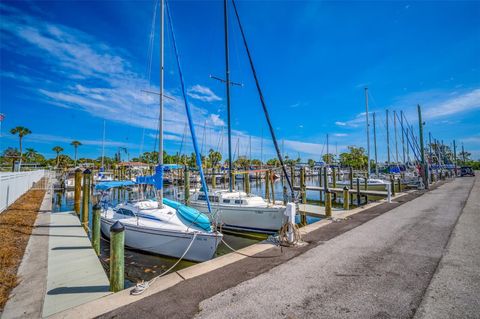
0, 170, 45, 213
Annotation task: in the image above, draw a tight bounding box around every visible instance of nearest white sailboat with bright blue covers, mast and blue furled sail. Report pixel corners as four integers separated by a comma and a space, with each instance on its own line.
101, 0, 223, 261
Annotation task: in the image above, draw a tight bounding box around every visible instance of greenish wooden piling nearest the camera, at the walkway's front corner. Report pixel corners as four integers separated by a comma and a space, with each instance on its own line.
110, 221, 125, 292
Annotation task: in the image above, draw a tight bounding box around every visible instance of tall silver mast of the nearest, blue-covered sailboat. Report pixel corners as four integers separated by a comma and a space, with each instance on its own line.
157, 0, 165, 207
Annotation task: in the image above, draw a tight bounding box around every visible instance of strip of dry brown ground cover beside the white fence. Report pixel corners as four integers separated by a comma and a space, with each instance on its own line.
0, 190, 45, 312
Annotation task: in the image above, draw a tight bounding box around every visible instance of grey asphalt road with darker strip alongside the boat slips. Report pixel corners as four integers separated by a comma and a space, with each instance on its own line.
101, 177, 480, 319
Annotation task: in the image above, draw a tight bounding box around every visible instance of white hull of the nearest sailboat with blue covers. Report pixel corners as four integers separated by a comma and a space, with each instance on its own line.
101, 216, 222, 262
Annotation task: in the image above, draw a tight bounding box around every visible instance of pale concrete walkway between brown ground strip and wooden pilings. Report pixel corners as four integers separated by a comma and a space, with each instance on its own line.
2, 190, 111, 319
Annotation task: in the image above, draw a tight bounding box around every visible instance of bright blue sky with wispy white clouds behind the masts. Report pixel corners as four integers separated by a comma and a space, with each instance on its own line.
0, 0, 480, 160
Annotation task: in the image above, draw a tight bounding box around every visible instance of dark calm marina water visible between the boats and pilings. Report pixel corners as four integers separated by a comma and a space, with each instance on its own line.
53, 181, 319, 285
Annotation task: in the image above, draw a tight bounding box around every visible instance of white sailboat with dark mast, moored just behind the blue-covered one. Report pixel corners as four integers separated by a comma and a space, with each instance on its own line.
185, 0, 290, 233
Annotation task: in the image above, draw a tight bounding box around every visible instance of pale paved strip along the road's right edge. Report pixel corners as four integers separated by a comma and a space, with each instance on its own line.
415, 172, 480, 319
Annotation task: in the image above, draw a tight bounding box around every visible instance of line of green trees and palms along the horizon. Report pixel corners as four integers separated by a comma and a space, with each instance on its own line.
0, 126, 480, 171
